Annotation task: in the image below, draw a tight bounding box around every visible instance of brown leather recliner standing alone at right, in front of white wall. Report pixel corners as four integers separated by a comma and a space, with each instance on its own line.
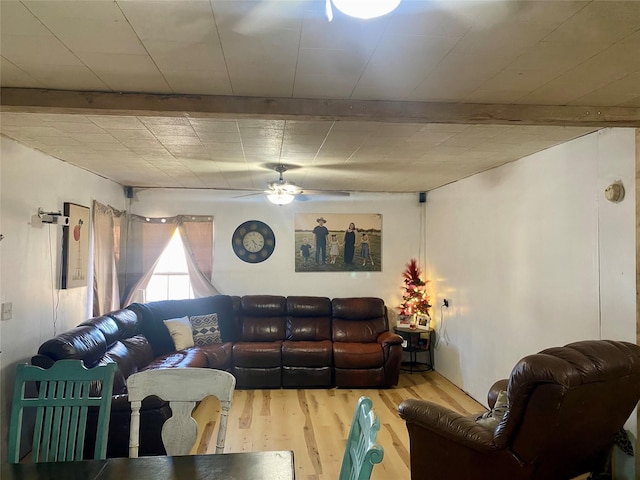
399, 340, 640, 480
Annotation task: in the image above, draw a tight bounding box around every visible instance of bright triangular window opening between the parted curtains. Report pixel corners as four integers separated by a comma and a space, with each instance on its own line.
144, 229, 193, 302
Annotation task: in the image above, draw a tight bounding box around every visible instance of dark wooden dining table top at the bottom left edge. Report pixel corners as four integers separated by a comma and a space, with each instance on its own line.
0, 450, 295, 480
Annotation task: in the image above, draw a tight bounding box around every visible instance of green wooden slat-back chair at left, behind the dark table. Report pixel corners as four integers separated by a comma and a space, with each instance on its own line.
8, 360, 117, 463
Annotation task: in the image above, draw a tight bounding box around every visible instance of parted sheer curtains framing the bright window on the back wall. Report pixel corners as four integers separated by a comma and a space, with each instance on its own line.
122, 215, 219, 306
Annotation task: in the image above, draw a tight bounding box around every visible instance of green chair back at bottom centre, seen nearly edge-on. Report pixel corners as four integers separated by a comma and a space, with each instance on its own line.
339, 396, 384, 480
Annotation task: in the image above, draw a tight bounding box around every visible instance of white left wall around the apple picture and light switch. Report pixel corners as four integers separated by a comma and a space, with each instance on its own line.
0, 137, 125, 459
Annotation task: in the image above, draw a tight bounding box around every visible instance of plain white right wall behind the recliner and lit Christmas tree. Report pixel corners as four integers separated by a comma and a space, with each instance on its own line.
426, 129, 636, 438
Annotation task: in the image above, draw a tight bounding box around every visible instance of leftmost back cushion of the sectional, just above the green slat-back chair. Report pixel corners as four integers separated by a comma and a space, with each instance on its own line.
38, 325, 107, 368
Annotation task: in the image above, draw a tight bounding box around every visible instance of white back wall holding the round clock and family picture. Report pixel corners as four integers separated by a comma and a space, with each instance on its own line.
130, 190, 424, 307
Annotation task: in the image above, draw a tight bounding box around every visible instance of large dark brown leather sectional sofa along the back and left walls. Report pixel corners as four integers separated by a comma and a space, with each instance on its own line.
32, 295, 402, 457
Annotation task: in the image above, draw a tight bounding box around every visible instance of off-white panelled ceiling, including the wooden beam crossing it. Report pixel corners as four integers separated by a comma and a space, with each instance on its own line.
0, 0, 640, 192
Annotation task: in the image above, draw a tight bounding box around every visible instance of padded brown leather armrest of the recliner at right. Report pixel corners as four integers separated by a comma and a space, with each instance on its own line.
398, 399, 496, 452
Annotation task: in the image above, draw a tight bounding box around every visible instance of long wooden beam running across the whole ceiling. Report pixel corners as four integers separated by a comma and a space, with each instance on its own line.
0, 87, 640, 127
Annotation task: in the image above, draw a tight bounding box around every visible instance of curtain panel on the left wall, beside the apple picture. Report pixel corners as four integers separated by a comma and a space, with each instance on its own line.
92, 200, 126, 317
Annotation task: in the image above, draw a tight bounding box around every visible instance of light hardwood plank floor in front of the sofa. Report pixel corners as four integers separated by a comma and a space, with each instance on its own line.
192, 372, 485, 480
